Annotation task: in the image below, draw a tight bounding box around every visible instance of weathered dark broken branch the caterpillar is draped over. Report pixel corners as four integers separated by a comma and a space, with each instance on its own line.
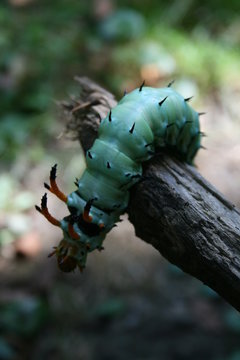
62, 78, 240, 311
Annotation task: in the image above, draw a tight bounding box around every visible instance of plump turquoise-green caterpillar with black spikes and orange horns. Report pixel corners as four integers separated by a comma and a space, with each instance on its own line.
36, 82, 203, 272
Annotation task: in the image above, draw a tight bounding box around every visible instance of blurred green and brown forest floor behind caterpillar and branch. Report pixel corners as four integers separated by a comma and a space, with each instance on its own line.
0, 0, 240, 360
